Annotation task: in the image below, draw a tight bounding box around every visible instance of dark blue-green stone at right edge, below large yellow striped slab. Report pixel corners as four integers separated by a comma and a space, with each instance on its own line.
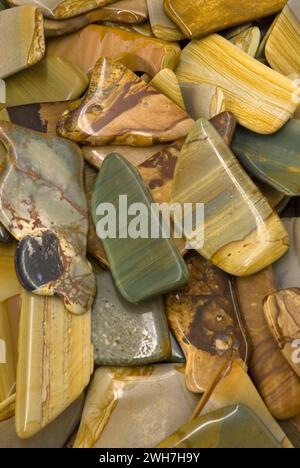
231, 119, 300, 196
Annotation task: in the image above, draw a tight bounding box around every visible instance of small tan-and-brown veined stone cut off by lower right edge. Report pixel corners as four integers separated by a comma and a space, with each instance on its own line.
264, 288, 300, 377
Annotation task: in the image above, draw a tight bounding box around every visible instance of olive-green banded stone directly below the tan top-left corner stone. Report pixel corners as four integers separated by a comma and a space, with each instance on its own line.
6, 57, 88, 107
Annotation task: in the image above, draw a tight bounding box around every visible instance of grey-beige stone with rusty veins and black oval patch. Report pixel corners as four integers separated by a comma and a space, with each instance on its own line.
0, 122, 95, 314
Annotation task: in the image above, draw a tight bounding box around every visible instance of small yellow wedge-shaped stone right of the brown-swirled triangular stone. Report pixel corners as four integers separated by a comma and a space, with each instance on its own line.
150, 68, 185, 109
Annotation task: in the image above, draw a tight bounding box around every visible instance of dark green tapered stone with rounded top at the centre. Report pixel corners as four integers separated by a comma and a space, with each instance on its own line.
92, 154, 188, 303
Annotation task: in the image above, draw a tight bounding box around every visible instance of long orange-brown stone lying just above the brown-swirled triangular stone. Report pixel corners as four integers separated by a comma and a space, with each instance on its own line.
47, 25, 180, 77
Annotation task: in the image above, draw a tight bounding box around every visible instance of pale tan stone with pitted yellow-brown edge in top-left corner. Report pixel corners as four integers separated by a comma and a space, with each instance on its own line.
0, 6, 45, 78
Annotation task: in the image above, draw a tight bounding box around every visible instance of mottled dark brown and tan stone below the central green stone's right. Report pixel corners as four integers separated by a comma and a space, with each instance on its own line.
166, 255, 250, 393
